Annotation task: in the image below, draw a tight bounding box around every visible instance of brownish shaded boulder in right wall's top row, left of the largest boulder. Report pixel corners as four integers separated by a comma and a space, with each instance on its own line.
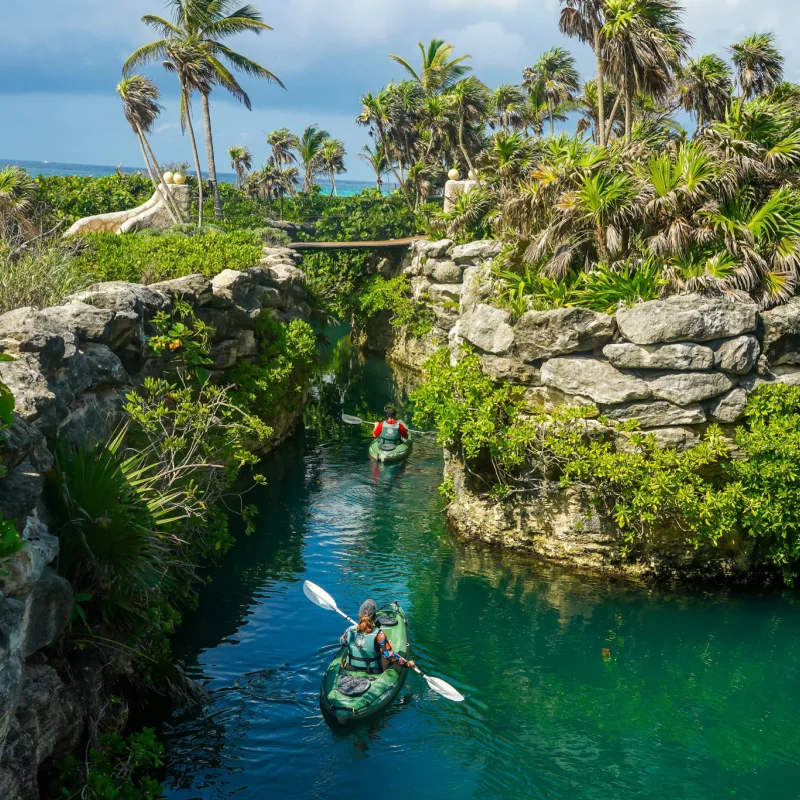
514, 308, 614, 361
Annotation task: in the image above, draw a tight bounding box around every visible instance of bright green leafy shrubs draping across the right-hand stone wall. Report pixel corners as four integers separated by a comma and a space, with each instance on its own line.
413, 350, 800, 582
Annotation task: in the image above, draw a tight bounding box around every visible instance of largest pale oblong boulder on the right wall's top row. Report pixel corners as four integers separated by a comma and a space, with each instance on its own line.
617, 294, 758, 344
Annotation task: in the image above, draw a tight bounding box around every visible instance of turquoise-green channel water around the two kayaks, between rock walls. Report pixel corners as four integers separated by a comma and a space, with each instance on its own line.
156, 336, 800, 800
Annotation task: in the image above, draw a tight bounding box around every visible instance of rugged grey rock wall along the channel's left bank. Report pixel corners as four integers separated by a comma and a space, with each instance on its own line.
0, 248, 311, 800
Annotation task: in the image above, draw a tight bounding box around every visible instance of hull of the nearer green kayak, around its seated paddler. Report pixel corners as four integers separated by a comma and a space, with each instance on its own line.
320, 601, 408, 725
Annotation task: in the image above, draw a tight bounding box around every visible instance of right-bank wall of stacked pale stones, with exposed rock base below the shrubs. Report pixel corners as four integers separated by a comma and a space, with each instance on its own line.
379, 240, 800, 575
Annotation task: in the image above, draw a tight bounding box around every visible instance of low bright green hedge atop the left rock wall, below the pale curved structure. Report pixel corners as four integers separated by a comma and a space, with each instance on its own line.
73, 231, 263, 283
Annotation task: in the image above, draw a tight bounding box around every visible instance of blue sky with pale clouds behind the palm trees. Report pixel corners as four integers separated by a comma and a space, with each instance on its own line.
0, 0, 800, 179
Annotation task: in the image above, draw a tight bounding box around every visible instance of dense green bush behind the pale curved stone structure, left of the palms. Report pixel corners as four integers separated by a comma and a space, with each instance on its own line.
36, 173, 153, 224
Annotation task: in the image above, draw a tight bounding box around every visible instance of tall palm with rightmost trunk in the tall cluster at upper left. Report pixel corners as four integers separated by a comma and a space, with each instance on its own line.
123, 0, 285, 219
